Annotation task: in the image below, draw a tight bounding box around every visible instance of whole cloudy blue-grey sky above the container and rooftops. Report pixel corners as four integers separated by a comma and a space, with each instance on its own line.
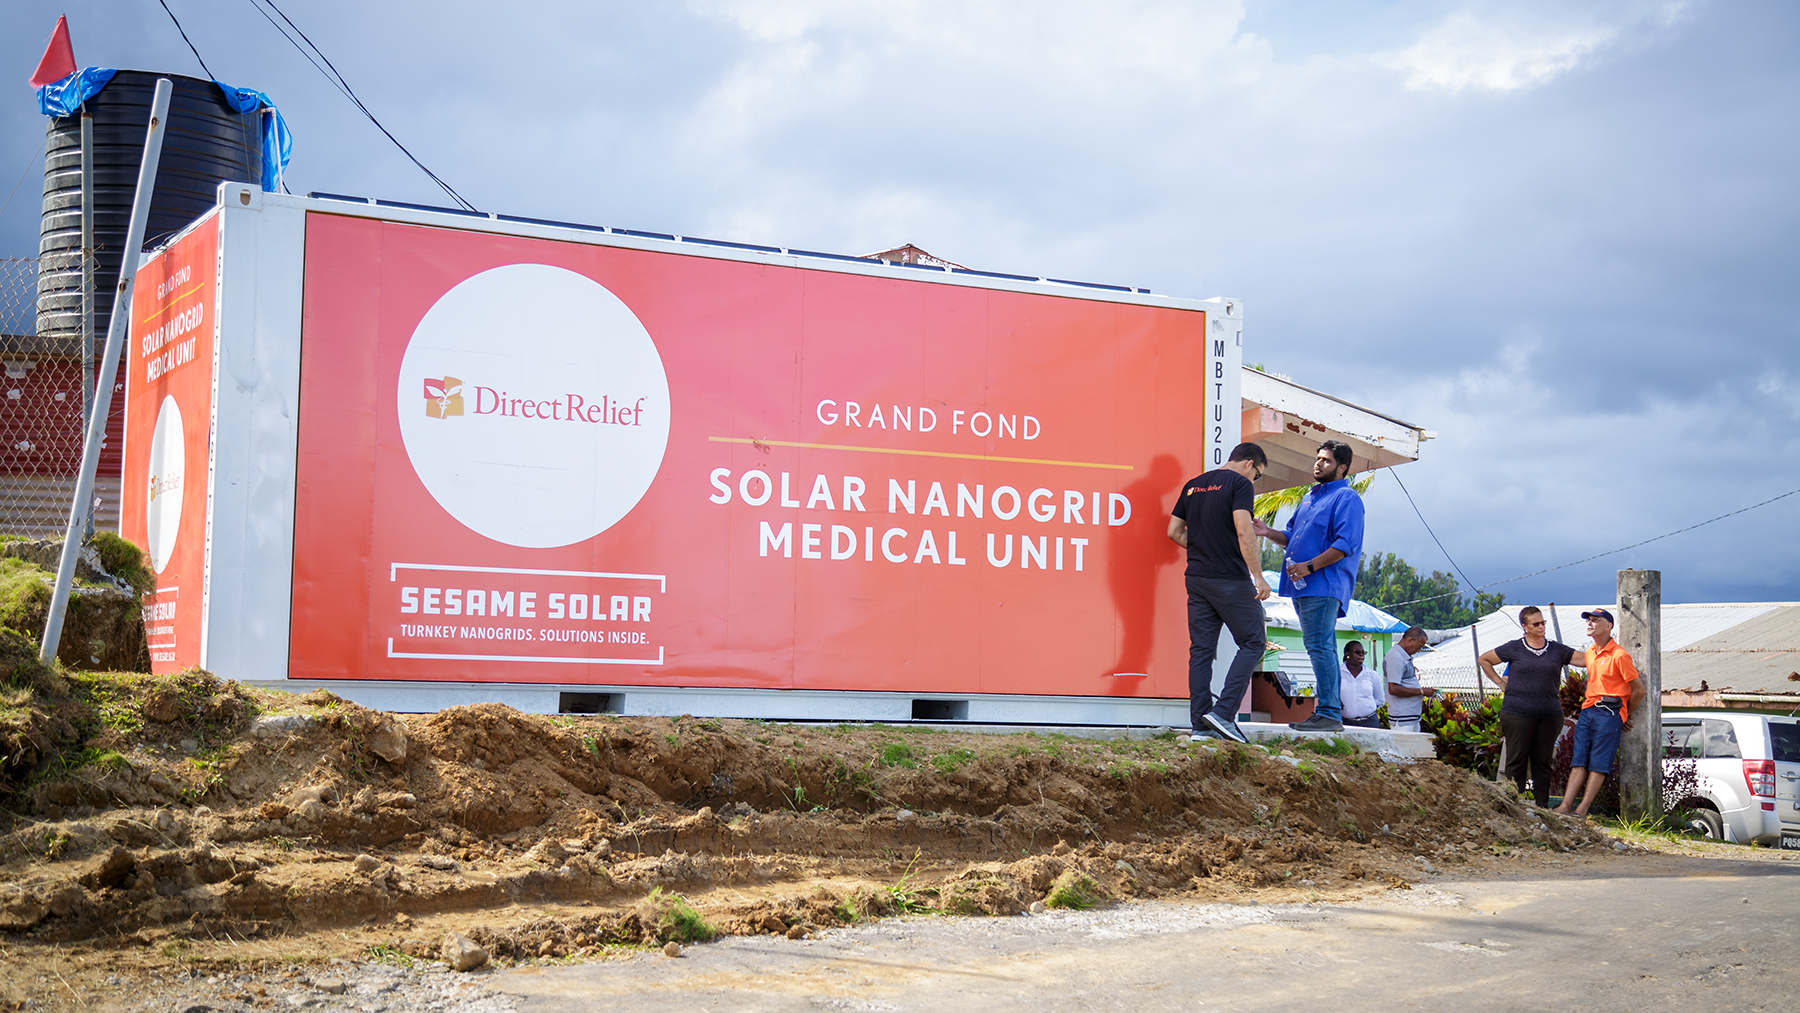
0, 0, 1800, 603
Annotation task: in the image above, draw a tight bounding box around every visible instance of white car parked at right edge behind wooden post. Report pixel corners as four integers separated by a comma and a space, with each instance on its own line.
1663, 711, 1800, 851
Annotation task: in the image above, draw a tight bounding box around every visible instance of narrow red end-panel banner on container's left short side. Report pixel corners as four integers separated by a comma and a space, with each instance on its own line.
121, 212, 220, 673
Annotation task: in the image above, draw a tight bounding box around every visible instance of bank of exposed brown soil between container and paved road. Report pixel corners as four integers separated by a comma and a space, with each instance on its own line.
0, 673, 1634, 1008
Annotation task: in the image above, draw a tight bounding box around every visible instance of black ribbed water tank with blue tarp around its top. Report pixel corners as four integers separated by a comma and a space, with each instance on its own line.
38, 70, 263, 354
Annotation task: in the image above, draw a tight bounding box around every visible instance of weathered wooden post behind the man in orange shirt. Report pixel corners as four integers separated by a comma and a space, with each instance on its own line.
1613, 570, 1663, 820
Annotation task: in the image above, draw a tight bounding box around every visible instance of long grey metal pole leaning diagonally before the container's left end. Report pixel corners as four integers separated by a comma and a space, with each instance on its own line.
38, 77, 175, 664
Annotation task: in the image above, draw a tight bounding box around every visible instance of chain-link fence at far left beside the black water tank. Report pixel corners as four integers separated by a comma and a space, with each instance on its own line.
0, 250, 124, 536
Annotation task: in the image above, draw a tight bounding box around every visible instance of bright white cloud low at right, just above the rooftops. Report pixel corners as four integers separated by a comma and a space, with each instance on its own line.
1364, 331, 1800, 601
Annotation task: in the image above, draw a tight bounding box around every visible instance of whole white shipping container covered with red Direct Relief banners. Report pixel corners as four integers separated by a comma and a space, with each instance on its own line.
122, 184, 1244, 725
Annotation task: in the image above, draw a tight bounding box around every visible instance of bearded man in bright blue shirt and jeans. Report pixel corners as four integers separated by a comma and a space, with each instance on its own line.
1255, 439, 1363, 732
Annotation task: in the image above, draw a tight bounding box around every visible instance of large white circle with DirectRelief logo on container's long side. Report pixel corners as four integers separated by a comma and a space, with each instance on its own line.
396, 264, 670, 549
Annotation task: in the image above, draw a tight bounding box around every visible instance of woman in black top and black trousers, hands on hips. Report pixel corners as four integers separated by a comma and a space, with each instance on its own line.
1481, 605, 1575, 808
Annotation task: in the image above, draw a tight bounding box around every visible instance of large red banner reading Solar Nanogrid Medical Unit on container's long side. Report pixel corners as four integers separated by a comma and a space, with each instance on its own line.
288, 214, 1206, 696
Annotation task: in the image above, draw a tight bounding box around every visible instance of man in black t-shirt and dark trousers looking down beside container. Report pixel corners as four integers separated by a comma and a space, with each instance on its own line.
1168, 443, 1269, 741
